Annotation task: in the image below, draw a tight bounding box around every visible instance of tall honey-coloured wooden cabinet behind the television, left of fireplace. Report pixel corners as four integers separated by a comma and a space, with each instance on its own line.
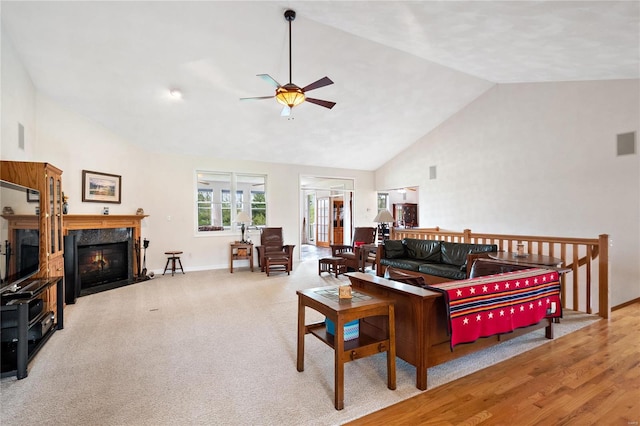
0, 161, 64, 312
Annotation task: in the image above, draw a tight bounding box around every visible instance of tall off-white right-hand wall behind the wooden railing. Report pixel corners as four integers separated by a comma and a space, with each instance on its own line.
376, 80, 640, 306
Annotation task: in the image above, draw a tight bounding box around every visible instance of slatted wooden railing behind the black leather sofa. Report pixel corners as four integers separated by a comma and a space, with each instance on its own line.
390, 227, 610, 318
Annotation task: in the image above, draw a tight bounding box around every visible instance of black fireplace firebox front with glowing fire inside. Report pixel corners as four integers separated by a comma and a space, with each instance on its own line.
78, 241, 129, 289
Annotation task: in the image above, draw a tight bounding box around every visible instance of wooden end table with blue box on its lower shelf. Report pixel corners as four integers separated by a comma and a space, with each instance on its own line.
296, 286, 396, 410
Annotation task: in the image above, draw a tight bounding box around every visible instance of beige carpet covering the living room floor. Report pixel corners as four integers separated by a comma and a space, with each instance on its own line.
0, 260, 595, 426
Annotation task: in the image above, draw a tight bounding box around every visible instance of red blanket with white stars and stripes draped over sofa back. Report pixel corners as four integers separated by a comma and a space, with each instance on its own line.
428, 268, 562, 349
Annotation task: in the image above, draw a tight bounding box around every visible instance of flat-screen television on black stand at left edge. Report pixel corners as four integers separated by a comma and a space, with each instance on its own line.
0, 180, 40, 293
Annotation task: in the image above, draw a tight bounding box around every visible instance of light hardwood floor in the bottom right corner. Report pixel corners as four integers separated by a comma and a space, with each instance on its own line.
348, 303, 640, 426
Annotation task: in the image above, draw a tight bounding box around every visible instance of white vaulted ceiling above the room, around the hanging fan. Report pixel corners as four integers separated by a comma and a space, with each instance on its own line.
0, 1, 640, 170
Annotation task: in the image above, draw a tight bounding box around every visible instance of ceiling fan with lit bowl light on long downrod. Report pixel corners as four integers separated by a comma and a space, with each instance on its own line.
240, 9, 336, 117
